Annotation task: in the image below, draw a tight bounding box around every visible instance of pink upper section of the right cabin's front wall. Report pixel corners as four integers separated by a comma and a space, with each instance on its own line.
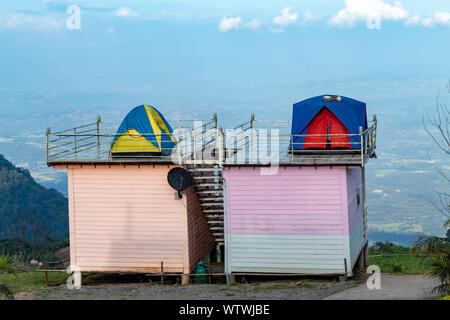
224, 166, 348, 235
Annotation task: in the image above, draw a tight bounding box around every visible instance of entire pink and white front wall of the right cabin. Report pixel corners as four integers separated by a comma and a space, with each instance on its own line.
224, 166, 349, 274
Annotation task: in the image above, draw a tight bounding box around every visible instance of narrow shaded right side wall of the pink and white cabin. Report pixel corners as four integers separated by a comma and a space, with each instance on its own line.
346, 168, 365, 267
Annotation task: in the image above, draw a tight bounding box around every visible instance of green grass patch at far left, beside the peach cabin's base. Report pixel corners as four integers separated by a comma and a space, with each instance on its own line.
0, 272, 69, 293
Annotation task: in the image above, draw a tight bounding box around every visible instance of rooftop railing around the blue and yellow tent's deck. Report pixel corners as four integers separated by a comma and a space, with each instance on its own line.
46, 114, 217, 164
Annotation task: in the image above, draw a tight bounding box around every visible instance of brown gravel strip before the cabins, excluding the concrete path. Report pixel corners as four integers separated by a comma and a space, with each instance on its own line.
16, 280, 361, 300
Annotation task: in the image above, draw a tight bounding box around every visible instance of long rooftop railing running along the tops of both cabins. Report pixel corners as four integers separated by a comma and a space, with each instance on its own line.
46, 114, 377, 166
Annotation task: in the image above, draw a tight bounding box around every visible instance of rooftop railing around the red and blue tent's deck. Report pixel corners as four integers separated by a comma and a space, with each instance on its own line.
224, 115, 377, 166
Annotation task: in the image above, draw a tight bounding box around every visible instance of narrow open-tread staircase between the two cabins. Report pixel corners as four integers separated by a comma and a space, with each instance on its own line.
187, 164, 224, 246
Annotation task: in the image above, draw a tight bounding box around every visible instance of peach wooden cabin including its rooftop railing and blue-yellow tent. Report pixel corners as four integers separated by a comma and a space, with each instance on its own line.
47, 114, 223, 283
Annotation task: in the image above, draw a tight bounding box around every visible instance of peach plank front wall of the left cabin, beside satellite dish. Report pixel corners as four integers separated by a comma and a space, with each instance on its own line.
64, 165, 205, 273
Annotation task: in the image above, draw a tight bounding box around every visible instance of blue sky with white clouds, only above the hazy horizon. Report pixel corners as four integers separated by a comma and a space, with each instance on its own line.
0, 0, 450, 98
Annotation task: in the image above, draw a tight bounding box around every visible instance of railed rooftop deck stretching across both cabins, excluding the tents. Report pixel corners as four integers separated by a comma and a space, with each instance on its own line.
46, 114, 377, 166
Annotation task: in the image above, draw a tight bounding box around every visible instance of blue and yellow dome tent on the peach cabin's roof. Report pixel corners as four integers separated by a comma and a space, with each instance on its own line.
111, 105, 175, 157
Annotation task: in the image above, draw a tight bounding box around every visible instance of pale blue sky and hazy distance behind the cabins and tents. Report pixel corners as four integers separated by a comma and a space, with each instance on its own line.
0, 0, 450, 238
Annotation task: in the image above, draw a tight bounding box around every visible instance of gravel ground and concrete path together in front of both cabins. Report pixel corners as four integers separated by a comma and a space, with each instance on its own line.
15, 274, 437, 300
